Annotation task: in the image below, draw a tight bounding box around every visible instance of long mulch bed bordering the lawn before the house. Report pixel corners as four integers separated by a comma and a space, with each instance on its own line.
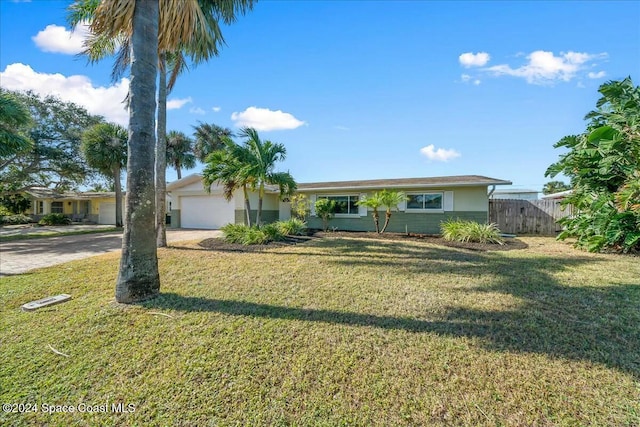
198, 231, 528, 252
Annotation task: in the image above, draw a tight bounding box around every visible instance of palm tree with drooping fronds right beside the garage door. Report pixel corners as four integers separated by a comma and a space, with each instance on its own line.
239, 127, 297, 226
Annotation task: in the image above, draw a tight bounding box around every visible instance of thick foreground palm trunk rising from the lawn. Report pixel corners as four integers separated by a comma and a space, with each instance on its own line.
116, 0, 160, 303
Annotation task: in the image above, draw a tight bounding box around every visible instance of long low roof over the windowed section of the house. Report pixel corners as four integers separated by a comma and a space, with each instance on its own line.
298, 175, 512, 191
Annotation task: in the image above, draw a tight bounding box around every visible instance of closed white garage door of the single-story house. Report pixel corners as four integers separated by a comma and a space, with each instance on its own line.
180, 196, 235, 229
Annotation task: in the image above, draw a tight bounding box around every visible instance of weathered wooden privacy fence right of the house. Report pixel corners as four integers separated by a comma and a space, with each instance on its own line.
489, 199, 571, 235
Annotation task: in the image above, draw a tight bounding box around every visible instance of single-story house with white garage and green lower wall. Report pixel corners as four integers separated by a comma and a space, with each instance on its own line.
167, 174, 511, 234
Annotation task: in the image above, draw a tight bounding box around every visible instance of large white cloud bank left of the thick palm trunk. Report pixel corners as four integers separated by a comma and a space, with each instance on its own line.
0, 63, 129, 126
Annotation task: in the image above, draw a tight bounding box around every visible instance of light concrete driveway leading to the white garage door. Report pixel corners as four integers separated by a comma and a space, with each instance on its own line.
0, 229, 222, 276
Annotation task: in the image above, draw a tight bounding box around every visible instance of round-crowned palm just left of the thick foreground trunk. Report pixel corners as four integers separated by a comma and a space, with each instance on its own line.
80, 123, 128, 227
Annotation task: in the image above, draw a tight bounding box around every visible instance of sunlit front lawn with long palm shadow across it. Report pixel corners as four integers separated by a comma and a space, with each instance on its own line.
0, 238, 640, 426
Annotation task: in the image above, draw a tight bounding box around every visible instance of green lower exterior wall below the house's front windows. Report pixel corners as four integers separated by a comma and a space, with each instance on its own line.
307, 211, 487, 234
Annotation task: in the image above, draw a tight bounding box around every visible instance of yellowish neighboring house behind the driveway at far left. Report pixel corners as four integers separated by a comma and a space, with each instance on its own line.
25, 187, 124, 224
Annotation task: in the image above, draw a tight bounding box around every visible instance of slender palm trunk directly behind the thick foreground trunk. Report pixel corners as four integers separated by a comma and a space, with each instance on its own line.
156, 53, 167, 248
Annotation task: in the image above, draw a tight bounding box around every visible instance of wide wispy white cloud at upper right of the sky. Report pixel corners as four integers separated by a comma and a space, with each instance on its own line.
487, 50, 607, 84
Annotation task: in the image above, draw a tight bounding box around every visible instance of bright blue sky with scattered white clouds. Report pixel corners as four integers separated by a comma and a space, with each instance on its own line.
0, 0, 640, 190
